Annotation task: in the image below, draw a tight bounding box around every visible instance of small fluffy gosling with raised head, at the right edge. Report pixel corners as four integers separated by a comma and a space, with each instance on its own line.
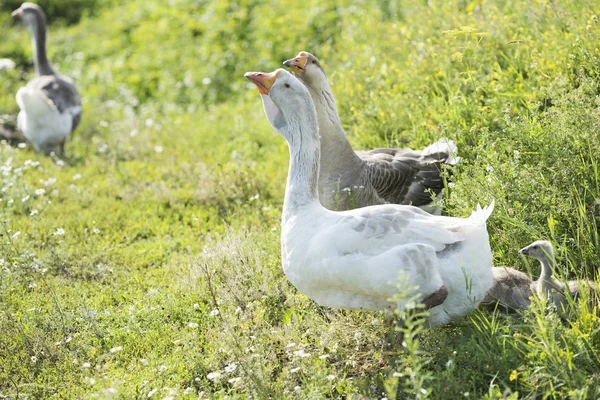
520, 240, 596, 316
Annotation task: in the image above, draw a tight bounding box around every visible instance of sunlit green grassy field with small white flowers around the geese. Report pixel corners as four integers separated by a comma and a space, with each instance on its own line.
0, 0, 600, 399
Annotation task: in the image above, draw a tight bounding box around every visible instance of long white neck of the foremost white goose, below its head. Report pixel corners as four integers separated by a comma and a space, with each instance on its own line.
282, 114, 320, 223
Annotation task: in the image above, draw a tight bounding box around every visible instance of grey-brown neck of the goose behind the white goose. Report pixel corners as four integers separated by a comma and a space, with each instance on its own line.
307, 80, 362, 170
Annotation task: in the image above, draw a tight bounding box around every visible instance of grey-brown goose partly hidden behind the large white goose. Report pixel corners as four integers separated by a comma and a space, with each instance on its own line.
284, 51, 457, 214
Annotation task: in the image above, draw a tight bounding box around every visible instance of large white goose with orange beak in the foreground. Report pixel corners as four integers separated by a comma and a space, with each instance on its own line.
245, 69, 493, 326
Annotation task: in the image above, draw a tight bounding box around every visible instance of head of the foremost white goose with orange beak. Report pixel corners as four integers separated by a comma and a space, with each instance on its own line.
244, 68, 318, 143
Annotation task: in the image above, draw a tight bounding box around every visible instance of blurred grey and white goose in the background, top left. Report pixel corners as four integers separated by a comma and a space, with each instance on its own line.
12, 3, 81, 154
